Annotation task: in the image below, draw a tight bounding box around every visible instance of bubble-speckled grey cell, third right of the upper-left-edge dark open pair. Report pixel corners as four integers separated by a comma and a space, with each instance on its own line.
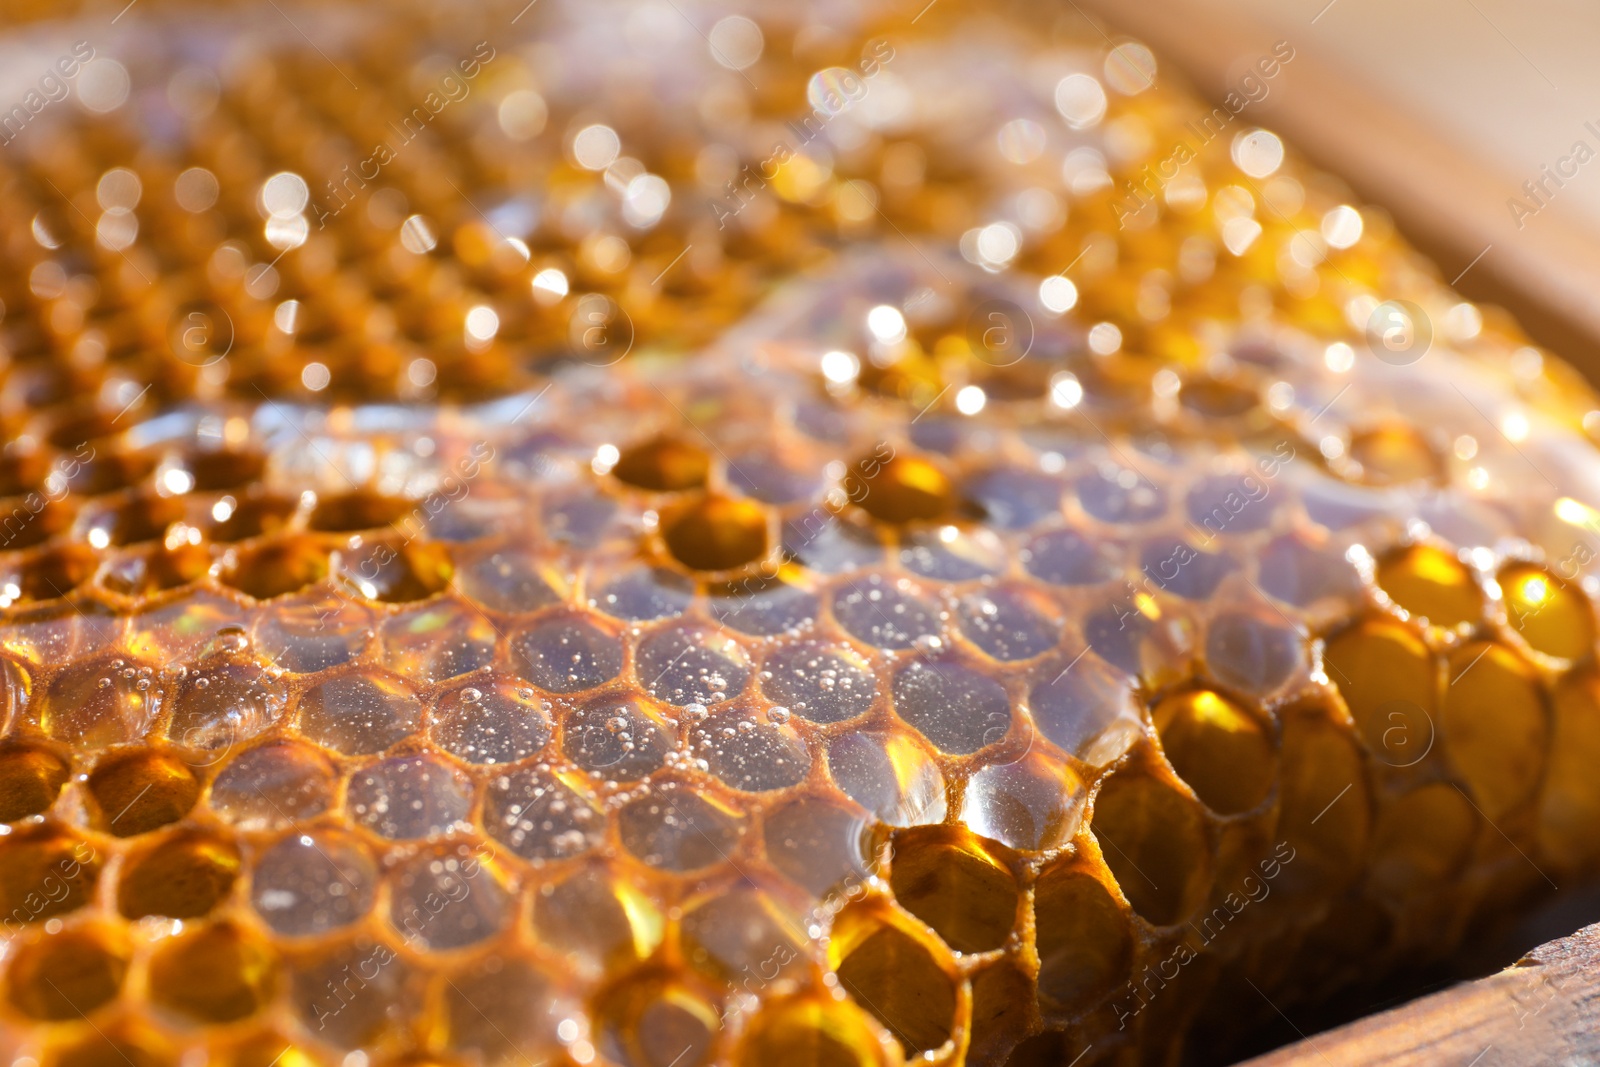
483, 768, 605, 862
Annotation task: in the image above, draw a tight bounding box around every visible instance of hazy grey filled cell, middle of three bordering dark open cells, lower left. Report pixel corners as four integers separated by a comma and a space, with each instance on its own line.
250, 830, 378, 937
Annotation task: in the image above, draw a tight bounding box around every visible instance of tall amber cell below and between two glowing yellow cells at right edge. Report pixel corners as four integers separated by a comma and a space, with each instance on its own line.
1438, 643, 1549, 819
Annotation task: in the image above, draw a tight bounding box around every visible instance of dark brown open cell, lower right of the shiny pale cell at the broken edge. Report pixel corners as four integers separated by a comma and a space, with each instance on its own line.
1034, 862, 1133, 1011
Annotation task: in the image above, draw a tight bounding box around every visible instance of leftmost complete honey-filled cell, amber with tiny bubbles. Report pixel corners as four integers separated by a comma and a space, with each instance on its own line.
37, 657, 155, 750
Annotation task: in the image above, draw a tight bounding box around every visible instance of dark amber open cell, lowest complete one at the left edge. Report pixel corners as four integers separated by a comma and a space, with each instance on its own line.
6, 929, 128, 1022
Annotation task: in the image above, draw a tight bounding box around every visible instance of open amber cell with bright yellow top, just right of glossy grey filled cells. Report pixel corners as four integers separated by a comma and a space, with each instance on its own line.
1150, 689, 1274, 814
